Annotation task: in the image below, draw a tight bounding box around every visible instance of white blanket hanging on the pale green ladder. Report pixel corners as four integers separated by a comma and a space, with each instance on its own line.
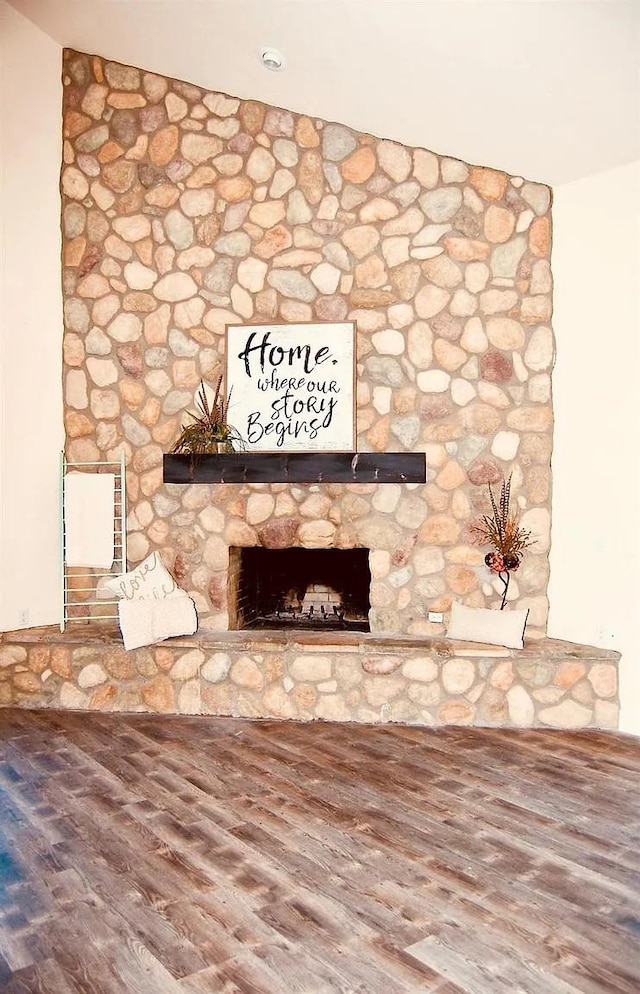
64, 472, 115, 570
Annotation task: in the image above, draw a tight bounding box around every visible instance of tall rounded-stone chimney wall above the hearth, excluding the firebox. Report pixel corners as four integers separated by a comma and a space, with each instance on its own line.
61, 51, 554, 636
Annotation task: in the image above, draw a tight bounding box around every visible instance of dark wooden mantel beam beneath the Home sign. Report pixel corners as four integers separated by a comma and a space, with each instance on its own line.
163, 452, 427, 483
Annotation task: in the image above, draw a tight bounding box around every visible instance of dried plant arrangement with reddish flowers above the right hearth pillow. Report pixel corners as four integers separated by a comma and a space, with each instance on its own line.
471, 477, 534, 611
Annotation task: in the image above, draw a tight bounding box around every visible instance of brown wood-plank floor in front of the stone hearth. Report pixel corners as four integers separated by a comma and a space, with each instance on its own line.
0, 710, 640, 994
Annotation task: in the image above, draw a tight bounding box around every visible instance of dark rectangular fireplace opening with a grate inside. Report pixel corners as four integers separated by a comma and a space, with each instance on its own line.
229, 548, 371, 632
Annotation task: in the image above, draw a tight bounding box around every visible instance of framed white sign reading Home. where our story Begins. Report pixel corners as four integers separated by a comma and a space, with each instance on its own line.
226, 322, 355, 452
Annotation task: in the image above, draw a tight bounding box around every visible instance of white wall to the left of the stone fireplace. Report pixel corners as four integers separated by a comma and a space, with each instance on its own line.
0, 0, 63, 631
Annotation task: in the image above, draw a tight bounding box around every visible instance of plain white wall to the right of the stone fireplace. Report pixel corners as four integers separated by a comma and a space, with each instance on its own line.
549, 162, 640, 735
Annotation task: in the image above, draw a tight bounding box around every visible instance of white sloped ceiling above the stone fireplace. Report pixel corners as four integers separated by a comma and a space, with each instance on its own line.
10, 0, 640, 185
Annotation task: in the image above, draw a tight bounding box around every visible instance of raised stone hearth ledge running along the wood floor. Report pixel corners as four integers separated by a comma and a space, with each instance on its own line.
0, 623, 620, 729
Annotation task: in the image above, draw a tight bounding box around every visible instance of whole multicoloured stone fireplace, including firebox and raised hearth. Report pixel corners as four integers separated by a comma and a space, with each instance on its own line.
8, 50, 617, 727
